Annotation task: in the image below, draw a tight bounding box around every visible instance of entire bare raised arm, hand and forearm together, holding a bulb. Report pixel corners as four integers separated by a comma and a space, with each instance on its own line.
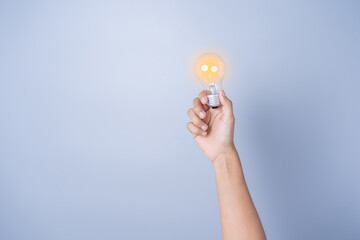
187, 91, 266, 240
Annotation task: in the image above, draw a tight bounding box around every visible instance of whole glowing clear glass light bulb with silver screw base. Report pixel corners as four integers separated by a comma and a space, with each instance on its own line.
195, 53, 225, 108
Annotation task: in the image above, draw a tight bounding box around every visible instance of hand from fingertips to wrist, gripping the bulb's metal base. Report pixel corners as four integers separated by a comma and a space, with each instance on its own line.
187, 90, 235, 162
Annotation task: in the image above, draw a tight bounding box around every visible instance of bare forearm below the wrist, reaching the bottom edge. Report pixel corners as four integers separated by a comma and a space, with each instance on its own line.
213, 149, 266, 240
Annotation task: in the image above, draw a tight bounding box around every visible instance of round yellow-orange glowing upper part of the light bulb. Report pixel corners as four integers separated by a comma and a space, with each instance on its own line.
195, 53, 225, 83
